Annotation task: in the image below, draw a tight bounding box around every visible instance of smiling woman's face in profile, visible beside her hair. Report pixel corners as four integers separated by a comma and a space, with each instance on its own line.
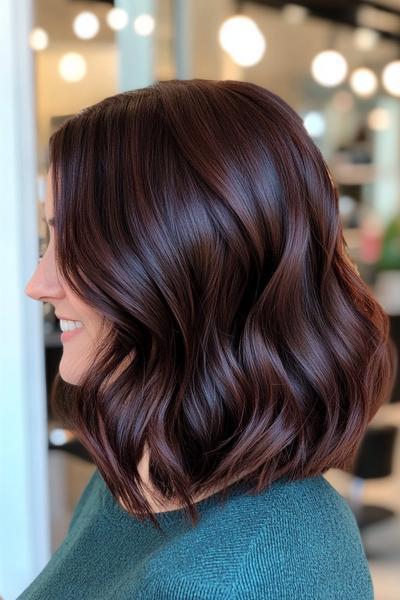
25, 171, 103, 384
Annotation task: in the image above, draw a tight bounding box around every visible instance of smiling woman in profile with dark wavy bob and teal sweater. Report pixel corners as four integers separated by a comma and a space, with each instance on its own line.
20, 79, 394, 600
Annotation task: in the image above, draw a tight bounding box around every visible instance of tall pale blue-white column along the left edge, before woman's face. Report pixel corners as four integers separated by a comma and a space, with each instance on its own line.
0, 0, 50, 600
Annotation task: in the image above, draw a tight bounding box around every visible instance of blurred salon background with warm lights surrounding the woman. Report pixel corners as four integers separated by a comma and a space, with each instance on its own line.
0, 0, 400, 600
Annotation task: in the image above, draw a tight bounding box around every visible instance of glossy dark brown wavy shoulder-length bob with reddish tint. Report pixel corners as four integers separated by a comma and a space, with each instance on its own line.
49, 79, 397, 530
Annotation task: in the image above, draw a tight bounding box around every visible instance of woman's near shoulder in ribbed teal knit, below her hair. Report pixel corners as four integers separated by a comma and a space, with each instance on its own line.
140, 476, 373, 600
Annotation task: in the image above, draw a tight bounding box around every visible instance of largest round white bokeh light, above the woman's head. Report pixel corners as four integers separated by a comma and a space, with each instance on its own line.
218, 15, 267, 67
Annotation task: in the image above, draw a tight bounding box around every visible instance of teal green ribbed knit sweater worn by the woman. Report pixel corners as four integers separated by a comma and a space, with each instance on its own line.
17, 469, 374, 600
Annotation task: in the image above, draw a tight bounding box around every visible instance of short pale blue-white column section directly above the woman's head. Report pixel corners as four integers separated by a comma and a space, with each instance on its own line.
114, 0, 157, 92
